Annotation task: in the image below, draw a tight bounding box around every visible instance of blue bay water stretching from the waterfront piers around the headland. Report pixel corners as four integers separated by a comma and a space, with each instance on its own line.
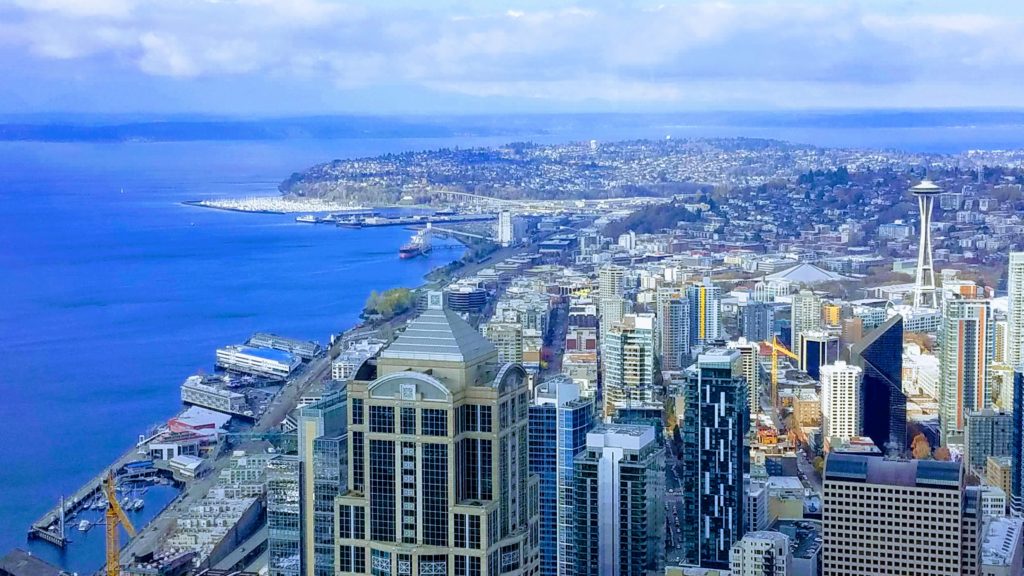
0, 117, 1024, 572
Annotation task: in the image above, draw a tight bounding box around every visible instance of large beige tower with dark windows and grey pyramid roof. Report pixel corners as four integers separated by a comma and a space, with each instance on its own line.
335, 292, 540, 576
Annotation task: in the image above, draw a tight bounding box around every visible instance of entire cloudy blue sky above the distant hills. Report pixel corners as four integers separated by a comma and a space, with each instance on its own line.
0, 0, 1024, 115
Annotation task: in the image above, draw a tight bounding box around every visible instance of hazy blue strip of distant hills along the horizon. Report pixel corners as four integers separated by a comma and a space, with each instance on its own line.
6, 110, 1024, 141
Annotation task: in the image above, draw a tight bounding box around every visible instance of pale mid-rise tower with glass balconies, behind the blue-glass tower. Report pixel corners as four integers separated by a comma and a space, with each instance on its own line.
601, 314, 655, 415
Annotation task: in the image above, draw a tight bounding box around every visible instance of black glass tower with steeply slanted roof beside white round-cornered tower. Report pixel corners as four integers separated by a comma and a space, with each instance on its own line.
850, 315, 908, 453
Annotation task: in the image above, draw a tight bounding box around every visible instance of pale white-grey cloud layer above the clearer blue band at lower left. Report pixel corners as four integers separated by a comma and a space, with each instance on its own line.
0, 0, 1024, 111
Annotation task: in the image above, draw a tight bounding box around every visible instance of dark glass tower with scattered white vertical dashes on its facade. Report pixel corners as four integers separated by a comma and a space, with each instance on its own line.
680, 348, 750, 569
